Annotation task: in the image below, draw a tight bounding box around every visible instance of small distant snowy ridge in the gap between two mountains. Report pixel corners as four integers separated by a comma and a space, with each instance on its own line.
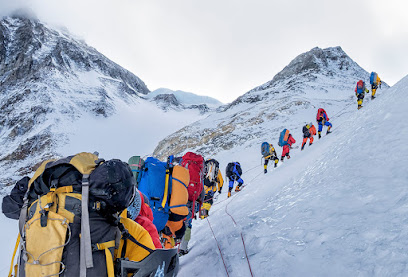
147, 88, 222, 108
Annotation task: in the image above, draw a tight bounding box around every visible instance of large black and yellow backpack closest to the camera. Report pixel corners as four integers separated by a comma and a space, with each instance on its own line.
10, 153, 136, 277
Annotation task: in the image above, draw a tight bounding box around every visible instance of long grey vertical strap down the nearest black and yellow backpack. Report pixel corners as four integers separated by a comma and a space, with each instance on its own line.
79, 174, 93, 277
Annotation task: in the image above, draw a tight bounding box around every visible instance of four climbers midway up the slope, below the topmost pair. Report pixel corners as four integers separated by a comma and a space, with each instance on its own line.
261, 108, 332, 174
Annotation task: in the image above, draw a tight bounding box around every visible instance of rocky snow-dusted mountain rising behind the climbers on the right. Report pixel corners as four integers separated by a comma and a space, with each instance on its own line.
154, 47, 387, 157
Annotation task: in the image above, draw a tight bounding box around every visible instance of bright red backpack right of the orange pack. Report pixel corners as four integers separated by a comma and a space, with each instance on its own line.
181, 152, 204, 205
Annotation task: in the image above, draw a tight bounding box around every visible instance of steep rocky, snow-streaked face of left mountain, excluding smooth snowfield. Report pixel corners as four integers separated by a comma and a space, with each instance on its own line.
0, 16, 210, 186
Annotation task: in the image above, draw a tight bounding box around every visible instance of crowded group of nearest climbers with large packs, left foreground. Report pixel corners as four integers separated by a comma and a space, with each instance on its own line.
2, 152, 244, 277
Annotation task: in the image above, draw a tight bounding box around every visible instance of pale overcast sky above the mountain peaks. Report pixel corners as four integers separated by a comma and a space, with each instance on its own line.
0, 0, 408, 102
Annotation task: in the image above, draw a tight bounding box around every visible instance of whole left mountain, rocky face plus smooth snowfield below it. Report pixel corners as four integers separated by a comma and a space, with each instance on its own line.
0, 16, 206, 188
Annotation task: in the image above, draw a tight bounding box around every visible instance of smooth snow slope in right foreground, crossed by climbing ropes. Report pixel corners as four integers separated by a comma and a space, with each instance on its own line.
179, 76, 408, 276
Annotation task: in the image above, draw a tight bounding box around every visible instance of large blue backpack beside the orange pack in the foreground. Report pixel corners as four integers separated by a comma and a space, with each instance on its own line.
138, 157, 171, 232
